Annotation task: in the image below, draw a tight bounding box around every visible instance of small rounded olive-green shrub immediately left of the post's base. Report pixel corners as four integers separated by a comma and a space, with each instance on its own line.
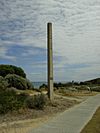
26, 94, 46, 109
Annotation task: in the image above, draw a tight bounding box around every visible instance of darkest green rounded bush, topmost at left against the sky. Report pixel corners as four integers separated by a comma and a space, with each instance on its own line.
0, 64, 26, 78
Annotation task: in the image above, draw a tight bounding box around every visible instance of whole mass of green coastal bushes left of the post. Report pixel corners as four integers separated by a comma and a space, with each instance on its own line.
0, 65, 46, 114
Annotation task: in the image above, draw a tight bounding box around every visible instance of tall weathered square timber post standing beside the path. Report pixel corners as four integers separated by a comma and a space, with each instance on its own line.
47, 23, 53, 101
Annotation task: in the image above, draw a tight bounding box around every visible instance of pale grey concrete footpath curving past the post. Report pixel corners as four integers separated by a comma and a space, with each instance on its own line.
28, 94, 100, 133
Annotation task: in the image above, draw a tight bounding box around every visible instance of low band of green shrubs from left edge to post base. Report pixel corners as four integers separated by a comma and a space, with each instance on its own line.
0, 90, 47, 114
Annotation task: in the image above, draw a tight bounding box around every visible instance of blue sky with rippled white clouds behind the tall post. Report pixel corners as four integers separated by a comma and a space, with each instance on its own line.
0, 0, 100, 81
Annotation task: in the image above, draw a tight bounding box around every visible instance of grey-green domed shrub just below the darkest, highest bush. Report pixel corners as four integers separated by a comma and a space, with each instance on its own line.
5, 74, 34, 90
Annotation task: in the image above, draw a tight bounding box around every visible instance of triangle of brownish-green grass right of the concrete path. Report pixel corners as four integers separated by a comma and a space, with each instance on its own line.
81, 107, 100, 133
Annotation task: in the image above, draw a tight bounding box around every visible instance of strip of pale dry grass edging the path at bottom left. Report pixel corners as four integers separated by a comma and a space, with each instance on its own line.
0, 117, 48, 133
